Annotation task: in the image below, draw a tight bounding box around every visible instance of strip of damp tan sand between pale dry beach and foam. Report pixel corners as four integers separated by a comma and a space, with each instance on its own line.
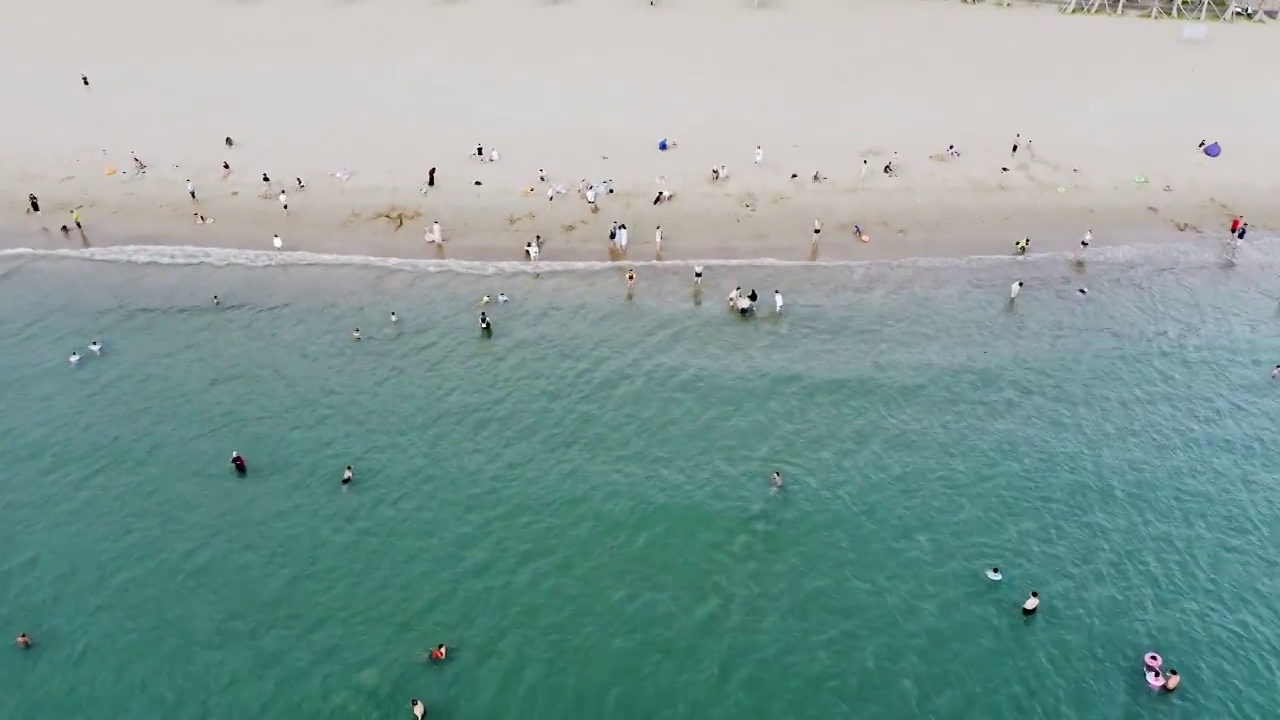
0, 187, 1259, 265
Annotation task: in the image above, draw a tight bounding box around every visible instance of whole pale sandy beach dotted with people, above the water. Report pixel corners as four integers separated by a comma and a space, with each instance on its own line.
0, 0, 1280, 261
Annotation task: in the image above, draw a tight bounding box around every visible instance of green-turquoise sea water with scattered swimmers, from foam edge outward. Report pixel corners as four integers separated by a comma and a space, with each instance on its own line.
0, 242, 1280, 720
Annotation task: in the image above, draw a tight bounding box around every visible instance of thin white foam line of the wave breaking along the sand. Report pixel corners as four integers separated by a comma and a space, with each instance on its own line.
0, 237, 1280, 275
